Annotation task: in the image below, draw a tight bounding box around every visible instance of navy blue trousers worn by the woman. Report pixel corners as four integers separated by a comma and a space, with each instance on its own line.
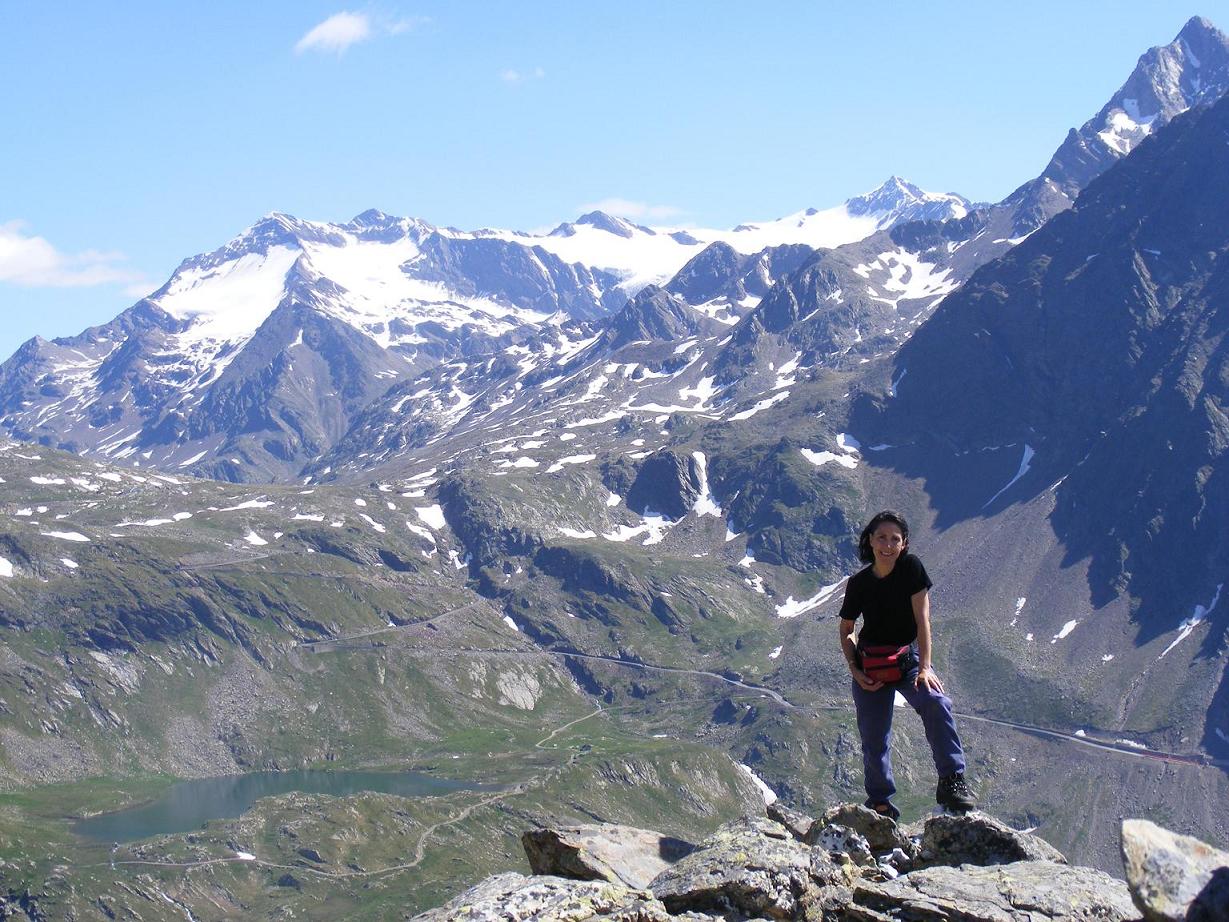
853, 670, 965, 806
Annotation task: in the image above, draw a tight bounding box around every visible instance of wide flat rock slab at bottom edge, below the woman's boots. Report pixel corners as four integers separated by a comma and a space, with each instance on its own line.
844, 861, 1139, 922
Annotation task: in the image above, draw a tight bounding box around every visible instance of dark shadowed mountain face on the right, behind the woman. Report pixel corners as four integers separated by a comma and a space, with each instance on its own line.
859, 90, 1229, 747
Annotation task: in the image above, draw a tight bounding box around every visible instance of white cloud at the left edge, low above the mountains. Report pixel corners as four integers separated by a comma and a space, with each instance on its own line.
0, 221, 156, 290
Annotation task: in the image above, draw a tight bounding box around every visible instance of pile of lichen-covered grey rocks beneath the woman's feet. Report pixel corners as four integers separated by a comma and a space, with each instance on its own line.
413, 804, 1229, 922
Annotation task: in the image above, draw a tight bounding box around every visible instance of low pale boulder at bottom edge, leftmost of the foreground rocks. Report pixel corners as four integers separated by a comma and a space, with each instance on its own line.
410, 872, 673, 922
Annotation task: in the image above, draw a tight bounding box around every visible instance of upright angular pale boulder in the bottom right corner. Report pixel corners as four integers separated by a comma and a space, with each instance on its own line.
1122, 820, 1229, 922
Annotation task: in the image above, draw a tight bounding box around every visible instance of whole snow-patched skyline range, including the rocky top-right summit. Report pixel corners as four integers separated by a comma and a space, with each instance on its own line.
0, 18, 1229, 479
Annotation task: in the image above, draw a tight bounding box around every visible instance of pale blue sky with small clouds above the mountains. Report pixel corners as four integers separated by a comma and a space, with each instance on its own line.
0, 0, 1229, 358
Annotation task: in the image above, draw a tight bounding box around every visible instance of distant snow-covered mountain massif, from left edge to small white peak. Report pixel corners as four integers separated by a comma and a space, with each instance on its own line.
0, 177, 968, 479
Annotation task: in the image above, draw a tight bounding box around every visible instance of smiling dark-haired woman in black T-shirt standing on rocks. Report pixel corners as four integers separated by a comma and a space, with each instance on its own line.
841, 511, 976, 820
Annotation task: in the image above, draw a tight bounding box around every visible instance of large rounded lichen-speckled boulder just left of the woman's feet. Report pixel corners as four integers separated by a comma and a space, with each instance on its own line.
649, 819, 854, 920
